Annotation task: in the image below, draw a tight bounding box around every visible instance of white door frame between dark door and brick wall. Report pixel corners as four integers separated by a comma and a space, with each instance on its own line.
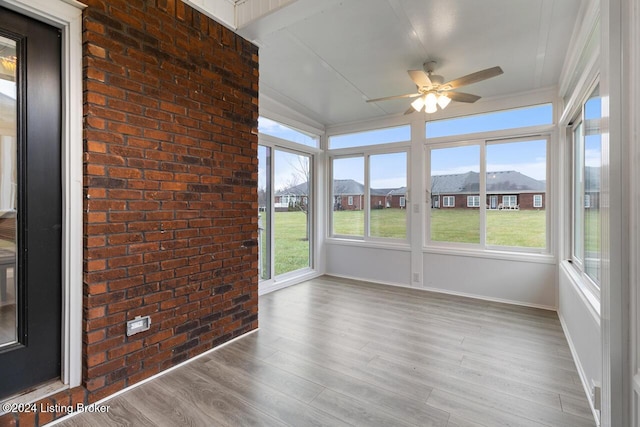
0, 0, 86, 394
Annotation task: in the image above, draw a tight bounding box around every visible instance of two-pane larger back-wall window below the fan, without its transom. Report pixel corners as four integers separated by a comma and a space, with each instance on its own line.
427, 138, 548, 251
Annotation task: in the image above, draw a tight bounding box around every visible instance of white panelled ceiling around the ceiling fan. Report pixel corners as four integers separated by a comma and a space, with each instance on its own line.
238, 0, 583, 126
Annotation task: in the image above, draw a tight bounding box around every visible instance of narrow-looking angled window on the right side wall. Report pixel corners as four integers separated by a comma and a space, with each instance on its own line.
572, 86, 602, 291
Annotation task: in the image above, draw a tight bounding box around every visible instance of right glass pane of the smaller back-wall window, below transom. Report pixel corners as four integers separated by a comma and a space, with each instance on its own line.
369, 152, 407, 239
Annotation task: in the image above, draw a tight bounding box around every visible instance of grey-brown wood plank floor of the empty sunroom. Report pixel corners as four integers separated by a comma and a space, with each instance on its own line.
59, 277, 595, 427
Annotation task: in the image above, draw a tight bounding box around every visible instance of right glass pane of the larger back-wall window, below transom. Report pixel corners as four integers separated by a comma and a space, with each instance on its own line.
486, 139, 547, 249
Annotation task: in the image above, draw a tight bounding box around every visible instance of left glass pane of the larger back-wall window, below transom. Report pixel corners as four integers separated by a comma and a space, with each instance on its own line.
429, 145, 480, 243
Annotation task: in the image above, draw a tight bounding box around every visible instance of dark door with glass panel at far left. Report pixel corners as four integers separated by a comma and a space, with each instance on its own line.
0, 8, 62, 399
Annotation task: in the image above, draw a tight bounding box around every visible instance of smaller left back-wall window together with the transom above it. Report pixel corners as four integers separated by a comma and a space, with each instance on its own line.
329, 125, 411, 242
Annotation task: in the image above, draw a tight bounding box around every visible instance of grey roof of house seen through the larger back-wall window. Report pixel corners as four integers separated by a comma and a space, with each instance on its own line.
431, 171, 546, 194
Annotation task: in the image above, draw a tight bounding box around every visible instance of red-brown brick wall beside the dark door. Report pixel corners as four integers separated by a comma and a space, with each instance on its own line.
0, 0, 258, 425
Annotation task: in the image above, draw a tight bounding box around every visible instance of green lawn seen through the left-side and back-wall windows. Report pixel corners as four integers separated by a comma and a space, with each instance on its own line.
262, 209, 546, 278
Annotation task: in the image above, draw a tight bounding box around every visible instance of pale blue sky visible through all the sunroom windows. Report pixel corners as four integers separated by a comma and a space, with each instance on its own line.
259, 98, 600, 191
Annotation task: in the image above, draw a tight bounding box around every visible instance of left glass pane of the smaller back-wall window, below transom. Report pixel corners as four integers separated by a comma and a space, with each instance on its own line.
331, 157, 364, 237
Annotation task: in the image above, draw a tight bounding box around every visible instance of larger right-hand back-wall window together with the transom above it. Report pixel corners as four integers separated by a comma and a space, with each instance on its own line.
426, 104, 553, 253
